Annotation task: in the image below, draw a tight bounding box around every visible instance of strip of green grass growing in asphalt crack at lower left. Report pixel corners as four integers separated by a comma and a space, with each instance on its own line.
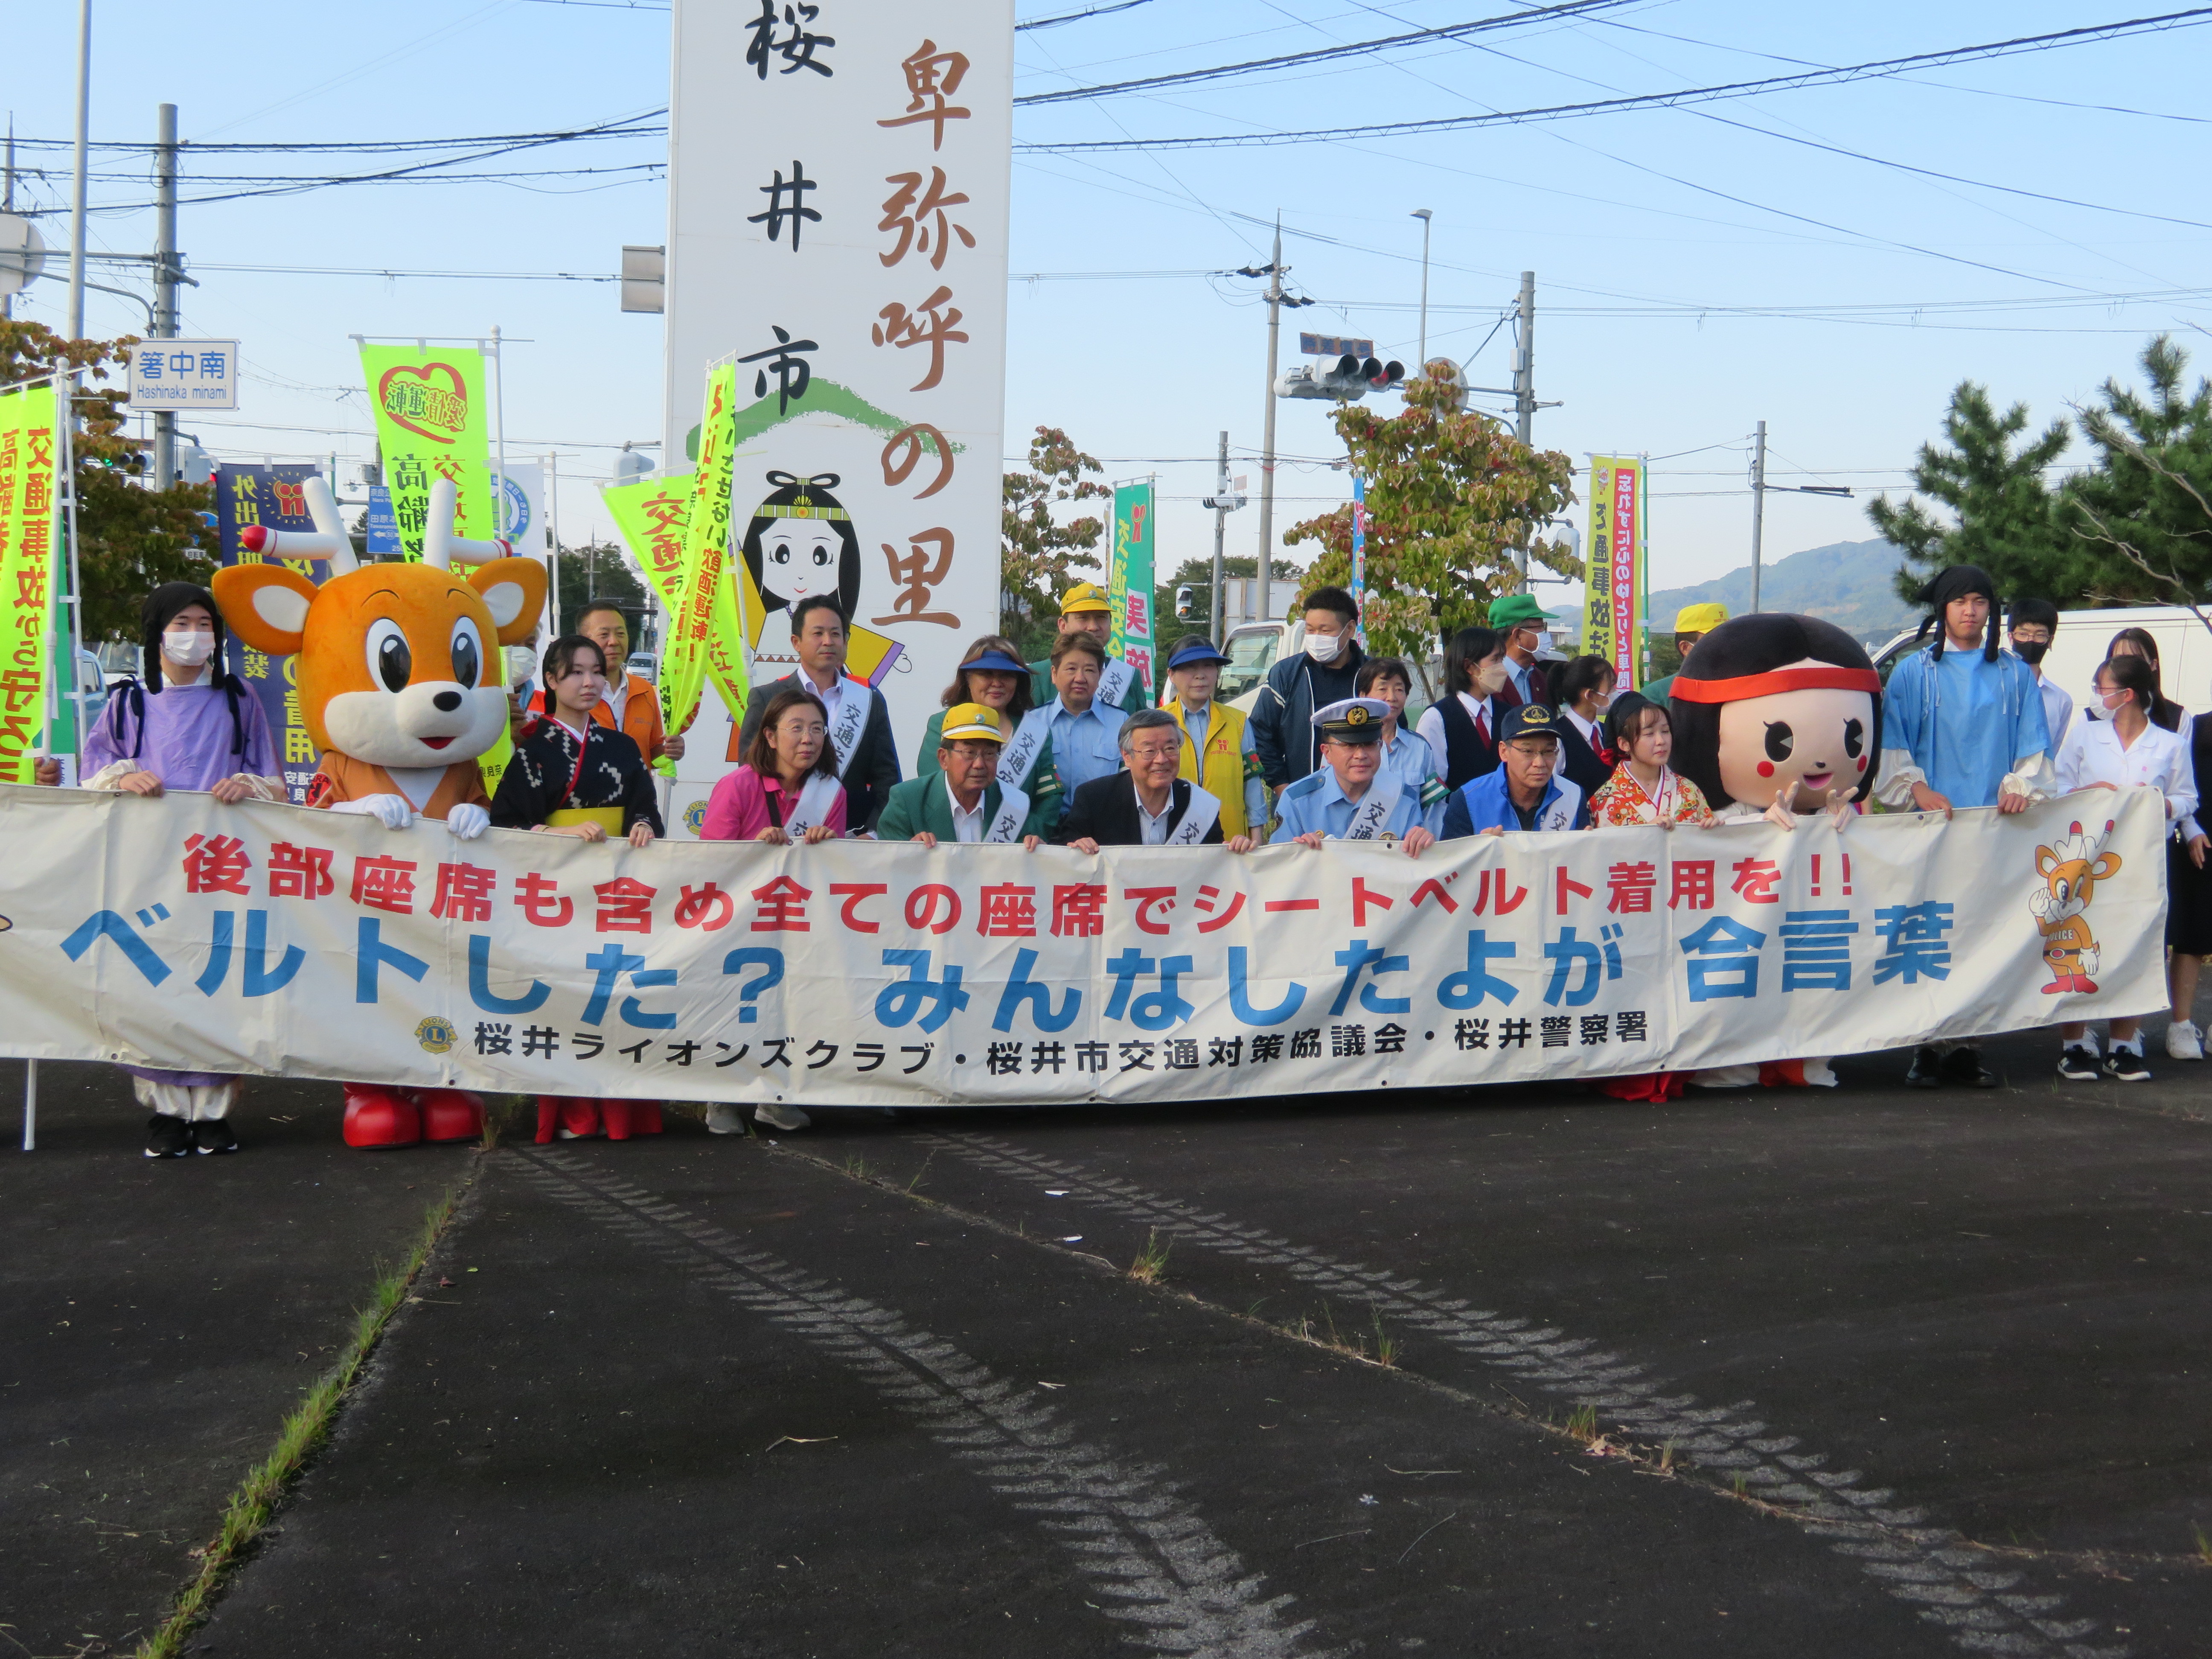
133, 1188, 460, 1659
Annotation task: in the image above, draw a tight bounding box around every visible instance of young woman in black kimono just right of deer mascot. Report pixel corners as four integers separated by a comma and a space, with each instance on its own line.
491, 635, 661, 1141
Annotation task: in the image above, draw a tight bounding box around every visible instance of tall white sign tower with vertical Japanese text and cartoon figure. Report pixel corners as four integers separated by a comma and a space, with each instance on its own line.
661, 0, 1013, 777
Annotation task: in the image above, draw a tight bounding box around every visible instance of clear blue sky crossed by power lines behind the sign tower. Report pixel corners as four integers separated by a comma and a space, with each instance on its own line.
7, 0, 2212, 586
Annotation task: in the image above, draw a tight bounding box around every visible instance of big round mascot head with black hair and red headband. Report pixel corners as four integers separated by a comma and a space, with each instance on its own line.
1668, 613, 1883, 809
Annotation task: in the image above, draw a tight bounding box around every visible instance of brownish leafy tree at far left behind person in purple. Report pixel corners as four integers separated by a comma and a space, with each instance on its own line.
0, 318, 217, 644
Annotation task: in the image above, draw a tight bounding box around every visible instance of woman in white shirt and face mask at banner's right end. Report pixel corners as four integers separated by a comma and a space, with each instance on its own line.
2046, 655, 2203, 1084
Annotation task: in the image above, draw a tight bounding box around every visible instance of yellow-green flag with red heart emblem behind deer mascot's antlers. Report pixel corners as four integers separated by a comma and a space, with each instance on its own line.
361, 345, 500, 560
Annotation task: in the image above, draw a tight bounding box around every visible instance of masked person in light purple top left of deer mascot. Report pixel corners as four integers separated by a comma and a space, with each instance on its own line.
71, 582, 285, 1157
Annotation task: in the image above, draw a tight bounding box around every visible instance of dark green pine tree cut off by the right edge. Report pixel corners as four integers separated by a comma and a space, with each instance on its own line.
2057, 334, 2212, 626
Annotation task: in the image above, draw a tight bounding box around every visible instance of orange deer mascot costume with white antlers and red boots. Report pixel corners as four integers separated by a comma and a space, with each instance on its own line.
215, 478, 546, 1146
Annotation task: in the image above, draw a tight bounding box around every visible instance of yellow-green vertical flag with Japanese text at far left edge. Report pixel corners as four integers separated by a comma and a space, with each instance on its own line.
0, 381, 55, 783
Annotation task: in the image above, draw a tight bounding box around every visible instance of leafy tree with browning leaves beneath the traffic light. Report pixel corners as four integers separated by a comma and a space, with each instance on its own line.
1283, 378, 1582, 661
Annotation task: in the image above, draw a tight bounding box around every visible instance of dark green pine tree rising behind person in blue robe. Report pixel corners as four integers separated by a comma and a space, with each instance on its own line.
1867, 381, 2088, 604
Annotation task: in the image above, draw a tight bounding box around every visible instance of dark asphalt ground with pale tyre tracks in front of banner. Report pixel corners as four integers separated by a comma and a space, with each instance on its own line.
0, 1037, 2212, 1659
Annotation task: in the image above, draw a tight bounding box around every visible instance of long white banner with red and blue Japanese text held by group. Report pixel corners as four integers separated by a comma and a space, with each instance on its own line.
0, 785, 2165, 1106
